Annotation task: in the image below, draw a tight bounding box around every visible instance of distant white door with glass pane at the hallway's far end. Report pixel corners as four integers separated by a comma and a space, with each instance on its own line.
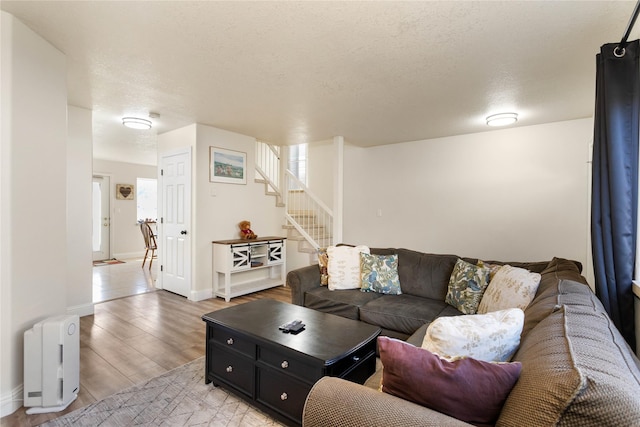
92, 175, 111, 261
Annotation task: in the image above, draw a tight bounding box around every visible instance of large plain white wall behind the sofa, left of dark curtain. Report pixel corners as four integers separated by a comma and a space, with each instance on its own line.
344, 119, 593, 282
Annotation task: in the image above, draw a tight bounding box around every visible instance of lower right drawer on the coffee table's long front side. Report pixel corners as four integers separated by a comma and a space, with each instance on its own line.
256, 368, 312, 423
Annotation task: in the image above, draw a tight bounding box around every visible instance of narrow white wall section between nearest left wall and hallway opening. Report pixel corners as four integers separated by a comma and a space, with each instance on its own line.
66, 105, 93, 316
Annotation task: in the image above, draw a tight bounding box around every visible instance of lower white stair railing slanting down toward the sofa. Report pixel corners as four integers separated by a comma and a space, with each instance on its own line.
284, 170, 333, 250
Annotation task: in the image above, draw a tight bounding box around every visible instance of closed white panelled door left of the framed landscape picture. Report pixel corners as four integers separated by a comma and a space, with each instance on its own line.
158, 149, 191, 298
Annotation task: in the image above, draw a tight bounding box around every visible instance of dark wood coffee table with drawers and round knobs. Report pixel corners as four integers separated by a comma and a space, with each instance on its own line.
202, 299, 380, 425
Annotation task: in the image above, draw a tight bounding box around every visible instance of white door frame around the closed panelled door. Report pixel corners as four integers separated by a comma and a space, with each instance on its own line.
156, 147, 195, 294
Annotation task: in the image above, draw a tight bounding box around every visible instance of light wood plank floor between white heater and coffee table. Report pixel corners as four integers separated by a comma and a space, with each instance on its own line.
0, 286, 291, 427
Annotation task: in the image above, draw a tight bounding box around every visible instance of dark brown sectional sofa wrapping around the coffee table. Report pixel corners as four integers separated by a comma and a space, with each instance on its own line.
287, 249, 640, 427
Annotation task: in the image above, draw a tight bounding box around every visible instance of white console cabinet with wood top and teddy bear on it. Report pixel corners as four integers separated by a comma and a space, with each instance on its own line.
212, 237, 287, 302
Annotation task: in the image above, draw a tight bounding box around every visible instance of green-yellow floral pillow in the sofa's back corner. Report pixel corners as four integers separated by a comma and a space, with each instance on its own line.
445, 259, 491, 314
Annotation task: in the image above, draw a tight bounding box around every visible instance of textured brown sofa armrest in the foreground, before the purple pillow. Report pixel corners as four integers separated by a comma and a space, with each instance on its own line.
302, 377, 471, 427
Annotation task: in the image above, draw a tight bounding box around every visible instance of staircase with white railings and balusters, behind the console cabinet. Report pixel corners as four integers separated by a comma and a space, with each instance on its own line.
256, 141, 333, 254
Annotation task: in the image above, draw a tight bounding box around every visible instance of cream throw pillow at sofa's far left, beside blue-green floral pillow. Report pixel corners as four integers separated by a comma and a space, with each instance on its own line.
327, 245, 370, 291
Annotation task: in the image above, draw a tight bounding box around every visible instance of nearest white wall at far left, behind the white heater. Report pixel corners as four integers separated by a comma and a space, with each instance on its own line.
0, 12, 68, 415
